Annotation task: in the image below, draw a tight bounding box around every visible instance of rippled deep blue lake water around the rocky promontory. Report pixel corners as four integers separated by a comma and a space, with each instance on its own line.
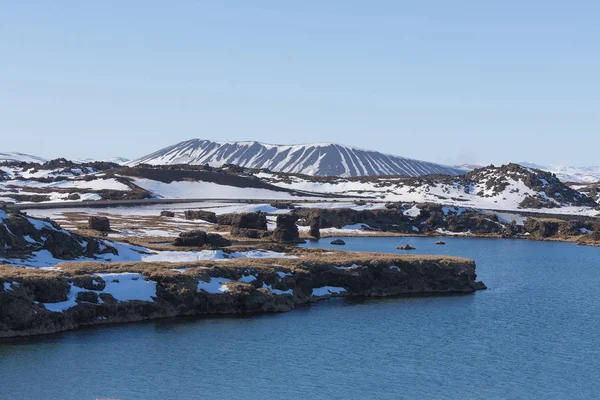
0, 238, 600, 400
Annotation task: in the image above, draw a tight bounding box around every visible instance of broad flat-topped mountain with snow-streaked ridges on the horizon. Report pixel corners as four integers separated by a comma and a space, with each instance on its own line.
129, 139, 464, 177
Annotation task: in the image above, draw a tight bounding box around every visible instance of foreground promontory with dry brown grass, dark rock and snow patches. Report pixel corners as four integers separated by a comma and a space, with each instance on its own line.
0, 251, 485, 338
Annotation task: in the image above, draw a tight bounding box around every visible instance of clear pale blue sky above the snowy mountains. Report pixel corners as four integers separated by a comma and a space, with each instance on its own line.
0, 0, 600, 165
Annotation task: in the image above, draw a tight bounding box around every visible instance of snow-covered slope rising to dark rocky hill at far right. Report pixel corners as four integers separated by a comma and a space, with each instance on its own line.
256, 164, 598, 215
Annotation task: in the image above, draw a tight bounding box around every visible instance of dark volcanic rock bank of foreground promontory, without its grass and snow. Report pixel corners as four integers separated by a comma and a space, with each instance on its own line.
0, 255, 485, 337
